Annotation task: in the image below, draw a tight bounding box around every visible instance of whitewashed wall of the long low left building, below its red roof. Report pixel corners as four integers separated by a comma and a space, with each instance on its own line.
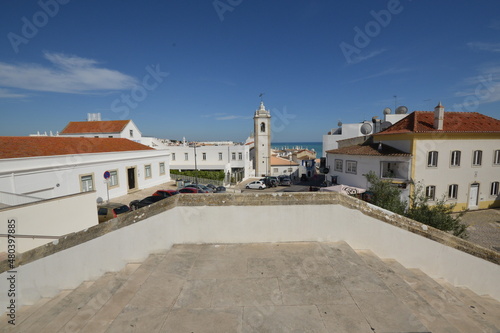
0, 150, 170, 199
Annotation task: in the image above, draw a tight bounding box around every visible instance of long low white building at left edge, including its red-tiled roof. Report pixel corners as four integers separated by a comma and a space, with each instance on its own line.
0, 137, 170, 200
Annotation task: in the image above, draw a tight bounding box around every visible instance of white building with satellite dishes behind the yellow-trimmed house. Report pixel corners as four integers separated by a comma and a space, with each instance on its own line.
323, 106, 408, 156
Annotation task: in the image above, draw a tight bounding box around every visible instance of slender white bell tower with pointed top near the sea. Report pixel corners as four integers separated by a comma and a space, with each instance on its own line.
253, 101, 271, 177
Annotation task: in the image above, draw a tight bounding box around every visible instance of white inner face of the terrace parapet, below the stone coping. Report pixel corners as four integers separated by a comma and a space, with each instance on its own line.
0, 198, 500, 309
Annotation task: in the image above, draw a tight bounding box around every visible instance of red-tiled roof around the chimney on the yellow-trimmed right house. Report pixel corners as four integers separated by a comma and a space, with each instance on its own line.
376, 111, 500, 135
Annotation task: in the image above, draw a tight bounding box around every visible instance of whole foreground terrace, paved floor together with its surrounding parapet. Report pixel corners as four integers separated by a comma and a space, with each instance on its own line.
0, 193, 500, 332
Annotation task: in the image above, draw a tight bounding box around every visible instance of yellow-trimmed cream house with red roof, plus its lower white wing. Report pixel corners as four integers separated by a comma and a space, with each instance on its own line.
327, 103, 500, 210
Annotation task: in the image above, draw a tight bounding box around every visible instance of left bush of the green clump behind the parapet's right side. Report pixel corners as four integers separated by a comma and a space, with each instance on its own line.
365, 171, 406, 215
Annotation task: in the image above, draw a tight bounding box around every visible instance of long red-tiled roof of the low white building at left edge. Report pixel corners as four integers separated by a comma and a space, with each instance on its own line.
0, 136, 154, 159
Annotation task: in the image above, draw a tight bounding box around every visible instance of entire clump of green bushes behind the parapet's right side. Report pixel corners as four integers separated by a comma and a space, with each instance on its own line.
365, 171, 468, 238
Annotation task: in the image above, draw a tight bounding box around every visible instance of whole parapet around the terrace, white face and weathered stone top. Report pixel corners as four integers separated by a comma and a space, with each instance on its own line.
0, 192, 500, 306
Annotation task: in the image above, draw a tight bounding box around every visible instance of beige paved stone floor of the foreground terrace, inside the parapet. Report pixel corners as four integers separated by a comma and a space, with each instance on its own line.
0, 242, 500, 333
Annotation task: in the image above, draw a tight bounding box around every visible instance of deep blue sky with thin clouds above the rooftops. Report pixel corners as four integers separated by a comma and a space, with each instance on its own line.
0, 0, 500, 142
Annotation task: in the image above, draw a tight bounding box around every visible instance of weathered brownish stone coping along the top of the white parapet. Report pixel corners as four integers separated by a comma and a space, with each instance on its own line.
0, 192, 500, 273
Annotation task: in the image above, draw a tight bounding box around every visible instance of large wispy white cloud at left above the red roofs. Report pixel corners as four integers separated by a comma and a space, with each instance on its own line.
0, 52, 137, 94
